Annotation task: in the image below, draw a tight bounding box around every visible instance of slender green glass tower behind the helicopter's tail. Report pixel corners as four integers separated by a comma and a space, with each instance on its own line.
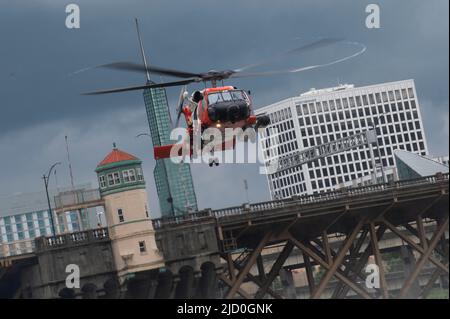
144, 87, 197, 217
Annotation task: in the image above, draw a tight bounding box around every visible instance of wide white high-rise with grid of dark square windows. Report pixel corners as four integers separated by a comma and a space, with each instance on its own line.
256, 80, 428, 198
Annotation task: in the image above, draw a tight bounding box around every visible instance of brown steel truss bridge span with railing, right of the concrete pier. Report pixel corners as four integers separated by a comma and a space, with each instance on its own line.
153, 174, 449, 299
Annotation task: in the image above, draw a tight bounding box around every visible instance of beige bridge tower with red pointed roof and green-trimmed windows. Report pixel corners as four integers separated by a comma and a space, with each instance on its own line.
95, 144, 163, 280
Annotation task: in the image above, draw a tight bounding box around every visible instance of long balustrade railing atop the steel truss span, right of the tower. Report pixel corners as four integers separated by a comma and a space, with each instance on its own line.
152, 173, 449, 229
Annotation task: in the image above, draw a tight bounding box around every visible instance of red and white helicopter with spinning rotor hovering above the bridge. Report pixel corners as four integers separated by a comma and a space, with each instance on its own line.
84, 21, 366, 166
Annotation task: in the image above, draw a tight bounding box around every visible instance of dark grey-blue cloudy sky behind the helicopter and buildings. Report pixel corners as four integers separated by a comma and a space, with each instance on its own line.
0, 0, 449, 217
